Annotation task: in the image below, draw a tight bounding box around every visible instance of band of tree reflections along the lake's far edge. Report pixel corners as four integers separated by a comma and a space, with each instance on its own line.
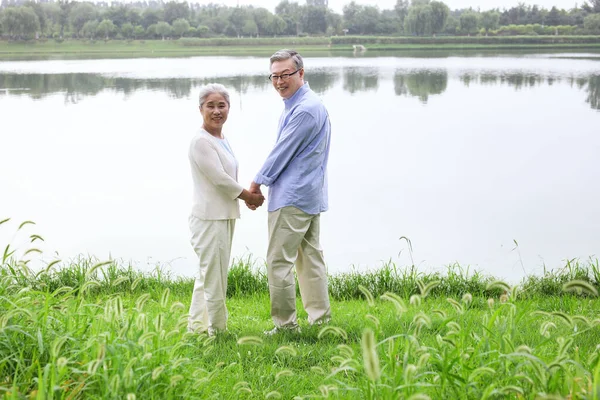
0, 67, 600, 110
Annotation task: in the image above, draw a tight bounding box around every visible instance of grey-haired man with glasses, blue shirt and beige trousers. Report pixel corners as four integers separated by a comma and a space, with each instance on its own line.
250, 49, 331, 334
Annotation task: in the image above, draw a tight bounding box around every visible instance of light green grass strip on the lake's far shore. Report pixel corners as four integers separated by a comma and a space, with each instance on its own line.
0, 38, 600, 59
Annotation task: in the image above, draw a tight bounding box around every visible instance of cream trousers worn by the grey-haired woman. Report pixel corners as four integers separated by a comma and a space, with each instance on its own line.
188, 216, 235, 332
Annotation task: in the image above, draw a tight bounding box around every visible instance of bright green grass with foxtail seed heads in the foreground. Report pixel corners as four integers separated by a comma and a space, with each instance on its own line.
0, 220, 600, 400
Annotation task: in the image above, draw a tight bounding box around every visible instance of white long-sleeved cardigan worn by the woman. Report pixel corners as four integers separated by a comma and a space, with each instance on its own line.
188, 129, 244, 220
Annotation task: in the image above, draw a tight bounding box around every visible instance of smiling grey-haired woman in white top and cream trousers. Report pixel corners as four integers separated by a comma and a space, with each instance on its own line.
188, 83, 264, 336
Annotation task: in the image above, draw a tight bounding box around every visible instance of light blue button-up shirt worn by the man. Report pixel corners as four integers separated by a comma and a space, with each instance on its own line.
254, 83, 331, 215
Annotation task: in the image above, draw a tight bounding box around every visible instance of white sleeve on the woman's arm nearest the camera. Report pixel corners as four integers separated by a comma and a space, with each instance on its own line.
191, 138, 244, 200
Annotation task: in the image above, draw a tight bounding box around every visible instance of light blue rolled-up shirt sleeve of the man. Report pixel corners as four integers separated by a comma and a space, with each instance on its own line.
254, 112, 318, 186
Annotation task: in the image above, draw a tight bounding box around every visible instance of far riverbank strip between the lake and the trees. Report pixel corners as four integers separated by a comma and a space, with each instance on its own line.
0, 36, 600, 59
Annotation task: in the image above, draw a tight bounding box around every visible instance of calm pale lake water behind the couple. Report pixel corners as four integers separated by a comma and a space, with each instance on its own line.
0, 53, 600, 279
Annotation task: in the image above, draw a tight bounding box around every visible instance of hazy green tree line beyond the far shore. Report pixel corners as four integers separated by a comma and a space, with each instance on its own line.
0, 0, 600, 40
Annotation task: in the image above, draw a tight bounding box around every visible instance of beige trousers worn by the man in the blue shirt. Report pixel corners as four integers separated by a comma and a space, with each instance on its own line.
267, 207, 331, 327
